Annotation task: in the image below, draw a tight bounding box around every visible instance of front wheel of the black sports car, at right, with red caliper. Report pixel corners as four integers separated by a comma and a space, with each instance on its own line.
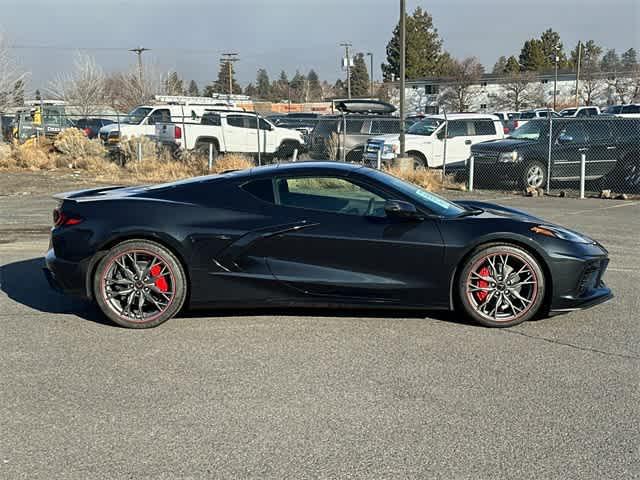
456, 243, 546, 327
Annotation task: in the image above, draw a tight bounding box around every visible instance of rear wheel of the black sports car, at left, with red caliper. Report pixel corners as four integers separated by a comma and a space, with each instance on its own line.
93, 240, 187, 328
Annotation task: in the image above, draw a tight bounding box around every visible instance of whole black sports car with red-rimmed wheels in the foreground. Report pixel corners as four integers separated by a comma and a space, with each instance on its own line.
45, 162, 612, 328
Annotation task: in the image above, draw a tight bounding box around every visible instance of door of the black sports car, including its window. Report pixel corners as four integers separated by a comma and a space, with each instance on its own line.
242, 175, 448, 305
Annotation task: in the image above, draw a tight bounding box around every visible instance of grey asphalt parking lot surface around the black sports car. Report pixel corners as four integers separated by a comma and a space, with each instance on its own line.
0, 173, 640, 480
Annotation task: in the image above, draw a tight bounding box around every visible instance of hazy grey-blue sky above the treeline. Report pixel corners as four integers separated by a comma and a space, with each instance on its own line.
0, 0, 640, 89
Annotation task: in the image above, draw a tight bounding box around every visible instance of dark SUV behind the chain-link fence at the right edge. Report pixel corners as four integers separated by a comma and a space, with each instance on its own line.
471, 117, 640, 190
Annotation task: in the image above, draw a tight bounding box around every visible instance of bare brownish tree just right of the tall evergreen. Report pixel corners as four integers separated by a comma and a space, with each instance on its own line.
441, 57, 484, 112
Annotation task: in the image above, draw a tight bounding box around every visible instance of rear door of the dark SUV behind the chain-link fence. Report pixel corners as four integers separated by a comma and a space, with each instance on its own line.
585, 118, 618, 178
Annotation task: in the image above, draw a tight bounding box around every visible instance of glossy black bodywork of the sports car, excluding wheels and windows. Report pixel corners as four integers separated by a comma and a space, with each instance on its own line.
46, 162, 611, 316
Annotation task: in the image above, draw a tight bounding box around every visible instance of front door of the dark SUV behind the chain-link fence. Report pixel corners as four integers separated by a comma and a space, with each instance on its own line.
550, 120, 589, 180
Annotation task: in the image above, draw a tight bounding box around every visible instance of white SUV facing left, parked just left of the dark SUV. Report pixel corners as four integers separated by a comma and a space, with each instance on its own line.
364, 113, 504, 168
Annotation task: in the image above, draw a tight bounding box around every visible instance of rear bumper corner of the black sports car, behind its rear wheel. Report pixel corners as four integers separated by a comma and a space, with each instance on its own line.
43, 249, 92, 298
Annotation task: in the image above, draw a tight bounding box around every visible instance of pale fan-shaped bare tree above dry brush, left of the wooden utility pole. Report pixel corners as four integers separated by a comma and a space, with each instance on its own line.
48, 52, 106, 117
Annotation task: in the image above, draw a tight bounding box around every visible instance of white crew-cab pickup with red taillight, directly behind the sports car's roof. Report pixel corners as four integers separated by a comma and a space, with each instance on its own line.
155, 109, 304, 159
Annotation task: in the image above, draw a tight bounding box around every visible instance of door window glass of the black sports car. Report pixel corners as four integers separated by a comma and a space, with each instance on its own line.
276, 177, 385, 216
